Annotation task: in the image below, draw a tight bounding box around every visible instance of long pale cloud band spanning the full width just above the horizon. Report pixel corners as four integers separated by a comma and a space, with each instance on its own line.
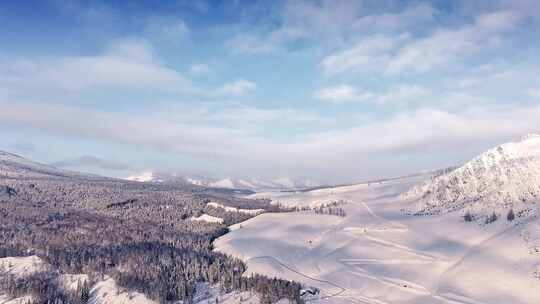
0, 98, 540, 182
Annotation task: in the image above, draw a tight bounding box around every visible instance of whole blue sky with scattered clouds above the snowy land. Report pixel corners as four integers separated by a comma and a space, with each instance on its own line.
0, 0, 540, 183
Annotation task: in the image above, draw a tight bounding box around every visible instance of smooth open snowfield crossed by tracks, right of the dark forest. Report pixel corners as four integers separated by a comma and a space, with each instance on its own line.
215, 175, 540, 304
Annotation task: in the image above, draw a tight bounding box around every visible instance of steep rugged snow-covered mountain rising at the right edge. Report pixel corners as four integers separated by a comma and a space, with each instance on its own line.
403, 135, 540, 216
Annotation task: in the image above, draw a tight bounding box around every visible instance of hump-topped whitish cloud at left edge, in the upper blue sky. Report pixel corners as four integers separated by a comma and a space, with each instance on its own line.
0, 41, 195, 94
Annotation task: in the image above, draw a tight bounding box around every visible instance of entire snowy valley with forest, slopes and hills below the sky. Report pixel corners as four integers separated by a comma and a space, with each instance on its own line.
0, 136, 540, 304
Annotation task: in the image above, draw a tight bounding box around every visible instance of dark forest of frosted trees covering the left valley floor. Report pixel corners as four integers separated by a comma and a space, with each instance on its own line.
0, 164, 302, 303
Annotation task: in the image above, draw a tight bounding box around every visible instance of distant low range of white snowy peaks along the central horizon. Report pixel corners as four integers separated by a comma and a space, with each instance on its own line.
126, 171, 319, 191
